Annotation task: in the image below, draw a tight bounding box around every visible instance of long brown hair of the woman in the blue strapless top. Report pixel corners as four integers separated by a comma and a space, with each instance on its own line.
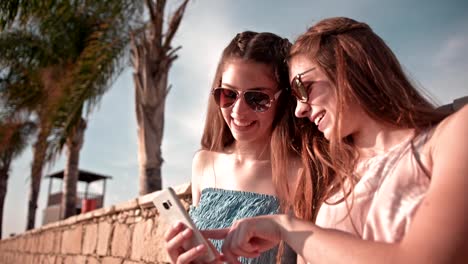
201, 31, 301, 208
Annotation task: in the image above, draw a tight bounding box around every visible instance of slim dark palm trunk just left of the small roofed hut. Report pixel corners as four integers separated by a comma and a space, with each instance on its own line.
26, 126, 50, 230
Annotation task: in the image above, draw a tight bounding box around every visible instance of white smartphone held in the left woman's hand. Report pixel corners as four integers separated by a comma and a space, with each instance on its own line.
153, 187, 216, 263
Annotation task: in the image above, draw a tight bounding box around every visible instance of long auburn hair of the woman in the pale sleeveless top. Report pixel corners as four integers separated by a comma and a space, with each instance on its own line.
290, 17, 446, 208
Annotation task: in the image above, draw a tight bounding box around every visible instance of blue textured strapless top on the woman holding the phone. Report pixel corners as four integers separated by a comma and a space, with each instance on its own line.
189, 188, 279, 264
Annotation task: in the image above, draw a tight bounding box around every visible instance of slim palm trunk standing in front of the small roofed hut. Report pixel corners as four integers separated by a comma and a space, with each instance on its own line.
61, 118, 86, 219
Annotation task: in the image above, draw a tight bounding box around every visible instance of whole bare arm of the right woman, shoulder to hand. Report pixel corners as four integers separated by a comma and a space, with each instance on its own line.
216, 106, 468, 264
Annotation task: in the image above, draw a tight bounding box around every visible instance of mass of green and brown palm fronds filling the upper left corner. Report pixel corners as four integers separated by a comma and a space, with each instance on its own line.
0, 0, 143, 158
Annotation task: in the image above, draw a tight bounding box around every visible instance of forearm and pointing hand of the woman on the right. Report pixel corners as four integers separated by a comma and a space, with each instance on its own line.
219, 215, 398, 263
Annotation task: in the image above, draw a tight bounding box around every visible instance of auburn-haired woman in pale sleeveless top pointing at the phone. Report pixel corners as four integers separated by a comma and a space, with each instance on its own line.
205, 17, 468, 263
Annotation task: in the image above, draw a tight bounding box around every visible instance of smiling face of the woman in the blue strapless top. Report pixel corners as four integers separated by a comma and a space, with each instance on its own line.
221, 60, 278, 144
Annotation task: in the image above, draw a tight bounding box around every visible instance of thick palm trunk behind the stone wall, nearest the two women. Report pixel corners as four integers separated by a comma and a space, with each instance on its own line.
131, 0, 188, 195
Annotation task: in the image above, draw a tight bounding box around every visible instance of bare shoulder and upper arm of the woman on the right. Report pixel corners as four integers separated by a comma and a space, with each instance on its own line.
402, 106, 468, 263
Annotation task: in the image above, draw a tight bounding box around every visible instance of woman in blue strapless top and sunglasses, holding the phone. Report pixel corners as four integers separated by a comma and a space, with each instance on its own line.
166, 31, 314, 263
